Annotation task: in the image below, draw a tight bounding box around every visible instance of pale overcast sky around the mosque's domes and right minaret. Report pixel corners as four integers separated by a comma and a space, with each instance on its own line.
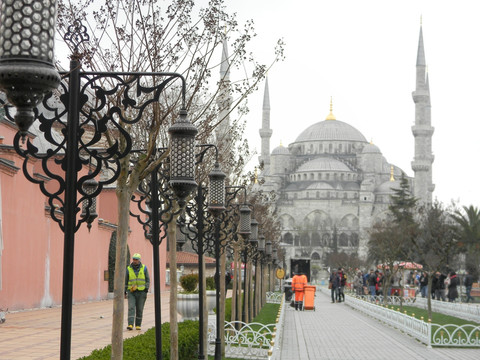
202, 0, 480, 206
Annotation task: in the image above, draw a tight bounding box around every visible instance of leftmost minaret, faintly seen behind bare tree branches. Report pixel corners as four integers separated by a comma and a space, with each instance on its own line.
215, 39, 232, 145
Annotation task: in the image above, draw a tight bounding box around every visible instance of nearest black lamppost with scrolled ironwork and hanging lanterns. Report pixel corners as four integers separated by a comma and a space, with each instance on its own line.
0, 7, 196, 360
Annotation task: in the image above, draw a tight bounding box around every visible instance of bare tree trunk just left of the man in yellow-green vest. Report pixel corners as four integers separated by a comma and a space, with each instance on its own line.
111, 186, 131, 360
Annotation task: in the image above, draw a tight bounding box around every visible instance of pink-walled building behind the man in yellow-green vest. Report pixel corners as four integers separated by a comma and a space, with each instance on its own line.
0, 116, 166, 310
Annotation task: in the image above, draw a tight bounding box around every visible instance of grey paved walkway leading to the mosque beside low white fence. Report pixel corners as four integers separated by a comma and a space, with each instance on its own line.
280, 290, 480, 360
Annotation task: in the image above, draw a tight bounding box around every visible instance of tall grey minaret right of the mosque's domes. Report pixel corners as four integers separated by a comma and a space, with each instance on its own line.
412, 26, 435, 205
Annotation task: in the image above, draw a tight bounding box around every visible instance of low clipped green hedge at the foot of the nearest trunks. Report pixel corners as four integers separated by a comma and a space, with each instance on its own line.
78, 320, 198, 360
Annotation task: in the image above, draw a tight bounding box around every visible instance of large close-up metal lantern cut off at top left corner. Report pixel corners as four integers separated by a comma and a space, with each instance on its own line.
0, 0, 60, 137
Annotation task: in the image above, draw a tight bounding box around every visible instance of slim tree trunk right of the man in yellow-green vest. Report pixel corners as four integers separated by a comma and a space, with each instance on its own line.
168, 224, 178, 360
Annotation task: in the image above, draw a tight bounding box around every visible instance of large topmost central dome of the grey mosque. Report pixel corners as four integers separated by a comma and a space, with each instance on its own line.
295, 120, 367, 142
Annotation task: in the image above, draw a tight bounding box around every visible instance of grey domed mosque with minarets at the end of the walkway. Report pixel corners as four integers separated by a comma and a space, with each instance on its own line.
255, 28, 435, 267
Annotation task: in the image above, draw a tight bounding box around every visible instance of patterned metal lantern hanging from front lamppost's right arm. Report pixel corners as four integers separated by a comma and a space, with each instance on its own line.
168, 110, 198, 205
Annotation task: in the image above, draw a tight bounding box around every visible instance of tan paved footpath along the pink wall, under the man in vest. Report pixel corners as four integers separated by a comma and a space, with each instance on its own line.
0, 292, 170, 360
